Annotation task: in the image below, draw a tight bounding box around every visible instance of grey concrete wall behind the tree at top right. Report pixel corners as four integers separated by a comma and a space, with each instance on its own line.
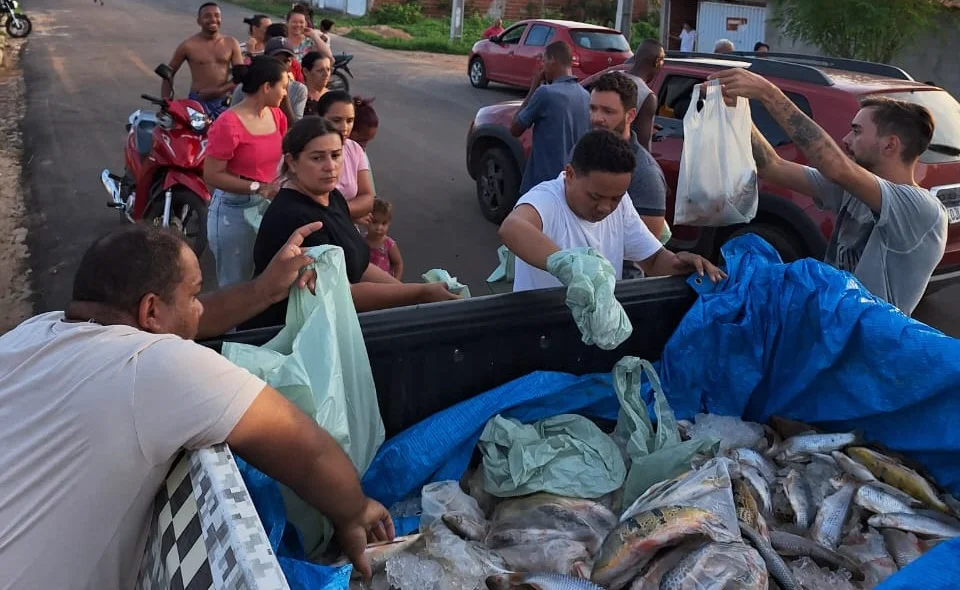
767, 10, 960, 98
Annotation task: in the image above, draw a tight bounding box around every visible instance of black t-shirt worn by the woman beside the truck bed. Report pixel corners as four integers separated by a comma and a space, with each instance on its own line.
240, 188, 370, 329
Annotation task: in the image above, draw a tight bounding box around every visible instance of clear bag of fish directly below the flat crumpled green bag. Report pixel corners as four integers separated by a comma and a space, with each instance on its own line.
485, 493, 617, 560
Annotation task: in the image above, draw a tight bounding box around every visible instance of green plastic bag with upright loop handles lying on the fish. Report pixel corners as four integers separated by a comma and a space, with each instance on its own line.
613, 356, 720, 505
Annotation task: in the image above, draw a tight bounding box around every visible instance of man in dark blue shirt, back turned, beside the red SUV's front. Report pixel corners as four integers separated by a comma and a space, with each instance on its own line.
510, 41, 590, 196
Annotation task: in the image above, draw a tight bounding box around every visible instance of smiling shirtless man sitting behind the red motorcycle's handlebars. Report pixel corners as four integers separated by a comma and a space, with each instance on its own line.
160, 2, 243, 119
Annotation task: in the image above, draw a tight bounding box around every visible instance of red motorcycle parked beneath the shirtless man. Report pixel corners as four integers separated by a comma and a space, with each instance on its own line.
100, 64, 211, 256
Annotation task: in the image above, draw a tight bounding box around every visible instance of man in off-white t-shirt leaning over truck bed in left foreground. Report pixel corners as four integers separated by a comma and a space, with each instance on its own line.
0, 223, 393, 590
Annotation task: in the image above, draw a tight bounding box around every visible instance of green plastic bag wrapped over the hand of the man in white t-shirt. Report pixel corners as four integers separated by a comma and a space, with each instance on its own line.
547, 248, 633, 350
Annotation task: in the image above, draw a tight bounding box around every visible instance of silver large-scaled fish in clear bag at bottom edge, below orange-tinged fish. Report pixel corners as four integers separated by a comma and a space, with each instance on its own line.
660, 543, 769, 590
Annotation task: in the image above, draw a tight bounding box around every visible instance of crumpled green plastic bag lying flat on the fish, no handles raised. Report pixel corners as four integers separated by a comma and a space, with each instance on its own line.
479, 414, 627, 498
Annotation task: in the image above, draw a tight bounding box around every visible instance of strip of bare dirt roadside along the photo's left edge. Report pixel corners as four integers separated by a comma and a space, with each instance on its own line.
0, 39, 33, 334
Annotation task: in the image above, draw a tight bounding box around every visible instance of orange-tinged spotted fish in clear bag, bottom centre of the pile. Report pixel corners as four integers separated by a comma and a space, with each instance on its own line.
591, 506, 736, 590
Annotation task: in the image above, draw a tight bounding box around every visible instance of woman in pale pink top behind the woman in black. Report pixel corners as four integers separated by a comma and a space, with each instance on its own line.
317, 90, 375, 222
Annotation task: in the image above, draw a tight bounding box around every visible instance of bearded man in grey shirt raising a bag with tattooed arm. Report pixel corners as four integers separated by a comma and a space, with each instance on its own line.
710, 68, 947, 315
